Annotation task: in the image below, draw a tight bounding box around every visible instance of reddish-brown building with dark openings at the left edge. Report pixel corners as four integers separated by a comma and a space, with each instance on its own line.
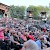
0, 3, 10, 18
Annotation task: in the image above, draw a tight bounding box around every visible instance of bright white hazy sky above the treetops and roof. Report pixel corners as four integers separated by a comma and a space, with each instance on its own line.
0, 0, 50, 7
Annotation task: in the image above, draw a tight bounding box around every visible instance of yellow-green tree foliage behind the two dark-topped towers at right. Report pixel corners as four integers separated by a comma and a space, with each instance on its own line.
27, 6, 50, 19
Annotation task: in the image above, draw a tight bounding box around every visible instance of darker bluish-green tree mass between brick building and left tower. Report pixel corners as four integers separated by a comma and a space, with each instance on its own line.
9, 5, 25, 19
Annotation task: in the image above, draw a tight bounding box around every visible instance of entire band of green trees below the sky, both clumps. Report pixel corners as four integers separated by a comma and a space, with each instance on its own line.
9, 5, 50, 19
